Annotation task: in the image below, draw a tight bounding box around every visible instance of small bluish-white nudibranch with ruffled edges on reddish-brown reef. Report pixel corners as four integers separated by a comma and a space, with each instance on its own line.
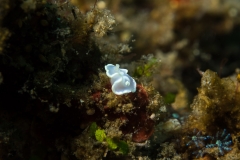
105, 64, 137, 95
